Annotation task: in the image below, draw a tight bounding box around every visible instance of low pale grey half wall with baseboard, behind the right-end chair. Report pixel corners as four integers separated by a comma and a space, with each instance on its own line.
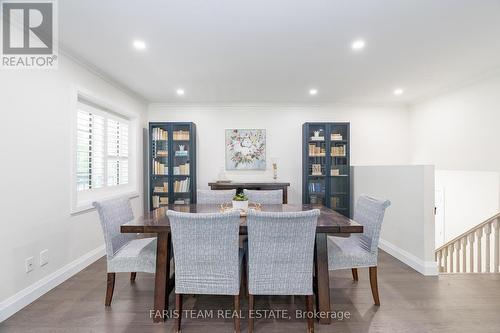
352, 165, 437, 275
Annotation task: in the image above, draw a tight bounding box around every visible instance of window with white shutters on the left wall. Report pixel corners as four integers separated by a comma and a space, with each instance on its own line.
75, 96, 135, 210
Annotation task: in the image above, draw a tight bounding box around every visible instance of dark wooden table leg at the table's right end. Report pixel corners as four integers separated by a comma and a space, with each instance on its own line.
314, 233, 331, 325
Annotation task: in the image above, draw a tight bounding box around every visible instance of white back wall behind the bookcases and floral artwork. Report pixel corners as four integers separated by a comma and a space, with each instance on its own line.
148, 104, 410, 203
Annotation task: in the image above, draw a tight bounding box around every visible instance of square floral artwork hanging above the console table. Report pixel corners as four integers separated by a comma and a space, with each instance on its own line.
226, 129, 266, 170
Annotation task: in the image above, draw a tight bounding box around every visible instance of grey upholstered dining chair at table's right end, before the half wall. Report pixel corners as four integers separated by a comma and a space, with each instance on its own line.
328, 195, 391, 305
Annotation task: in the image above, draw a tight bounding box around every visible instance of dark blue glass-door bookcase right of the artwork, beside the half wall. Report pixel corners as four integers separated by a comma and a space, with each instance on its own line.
302, 122, 351, 217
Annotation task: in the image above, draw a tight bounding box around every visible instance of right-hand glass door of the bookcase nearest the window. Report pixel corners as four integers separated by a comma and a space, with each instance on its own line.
171, 124, 189, 204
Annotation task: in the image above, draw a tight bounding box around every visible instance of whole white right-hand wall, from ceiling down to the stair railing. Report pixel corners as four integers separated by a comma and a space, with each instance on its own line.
410, 76, 500, 238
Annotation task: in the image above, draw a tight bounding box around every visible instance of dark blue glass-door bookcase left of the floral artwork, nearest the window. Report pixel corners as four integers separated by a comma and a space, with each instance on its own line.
149, 122, 196, 210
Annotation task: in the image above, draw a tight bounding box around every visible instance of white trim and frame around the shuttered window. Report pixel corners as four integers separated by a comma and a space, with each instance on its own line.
70, 86, 140, 215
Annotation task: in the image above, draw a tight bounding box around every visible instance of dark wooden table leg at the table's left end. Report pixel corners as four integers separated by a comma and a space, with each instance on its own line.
153, 232, 170, 323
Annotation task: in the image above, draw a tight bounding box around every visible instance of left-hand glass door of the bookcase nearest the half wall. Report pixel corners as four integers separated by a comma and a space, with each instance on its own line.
306, 124, 327, 205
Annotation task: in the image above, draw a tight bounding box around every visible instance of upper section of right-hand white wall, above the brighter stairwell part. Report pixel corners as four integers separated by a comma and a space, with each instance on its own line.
410, 77, 500, 172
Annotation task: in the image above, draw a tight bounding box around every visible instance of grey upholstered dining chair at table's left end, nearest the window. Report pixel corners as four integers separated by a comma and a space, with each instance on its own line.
92, 197, 156, 306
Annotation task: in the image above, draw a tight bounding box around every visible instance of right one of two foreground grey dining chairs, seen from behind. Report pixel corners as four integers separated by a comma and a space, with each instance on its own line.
247, 209, 320, 333
